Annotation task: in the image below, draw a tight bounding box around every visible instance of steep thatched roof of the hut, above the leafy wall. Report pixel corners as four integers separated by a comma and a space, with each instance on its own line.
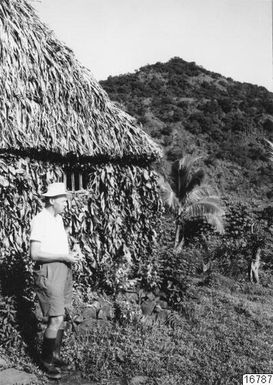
0, 0, 160, 161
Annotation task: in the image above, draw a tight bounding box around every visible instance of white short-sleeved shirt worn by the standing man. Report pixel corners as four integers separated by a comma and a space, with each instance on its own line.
30, 209, 69, 254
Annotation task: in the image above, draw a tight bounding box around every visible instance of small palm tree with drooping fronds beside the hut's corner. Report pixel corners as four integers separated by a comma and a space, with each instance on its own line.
159, 155, 224, 251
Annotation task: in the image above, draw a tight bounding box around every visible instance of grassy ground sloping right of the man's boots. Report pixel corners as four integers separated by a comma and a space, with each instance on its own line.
51, 275, 273, 385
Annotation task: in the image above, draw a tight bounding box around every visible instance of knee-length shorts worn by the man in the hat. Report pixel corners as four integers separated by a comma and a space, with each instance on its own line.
34, 262, 72, 317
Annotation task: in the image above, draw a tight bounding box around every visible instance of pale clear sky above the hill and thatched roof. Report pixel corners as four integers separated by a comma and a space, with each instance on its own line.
32, 0, 273, 91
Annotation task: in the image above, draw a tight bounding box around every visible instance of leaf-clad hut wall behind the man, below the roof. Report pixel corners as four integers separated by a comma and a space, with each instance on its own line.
0, 156, 160, 294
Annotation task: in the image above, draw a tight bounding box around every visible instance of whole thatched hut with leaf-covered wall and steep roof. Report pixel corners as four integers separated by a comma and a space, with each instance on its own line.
0, 0, 160, 295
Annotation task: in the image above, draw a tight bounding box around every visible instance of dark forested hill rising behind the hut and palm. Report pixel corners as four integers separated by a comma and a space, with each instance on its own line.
101, 57, 273, 203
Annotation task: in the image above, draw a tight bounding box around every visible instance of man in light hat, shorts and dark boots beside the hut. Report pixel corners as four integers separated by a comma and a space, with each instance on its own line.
30, 183, 78, 379
